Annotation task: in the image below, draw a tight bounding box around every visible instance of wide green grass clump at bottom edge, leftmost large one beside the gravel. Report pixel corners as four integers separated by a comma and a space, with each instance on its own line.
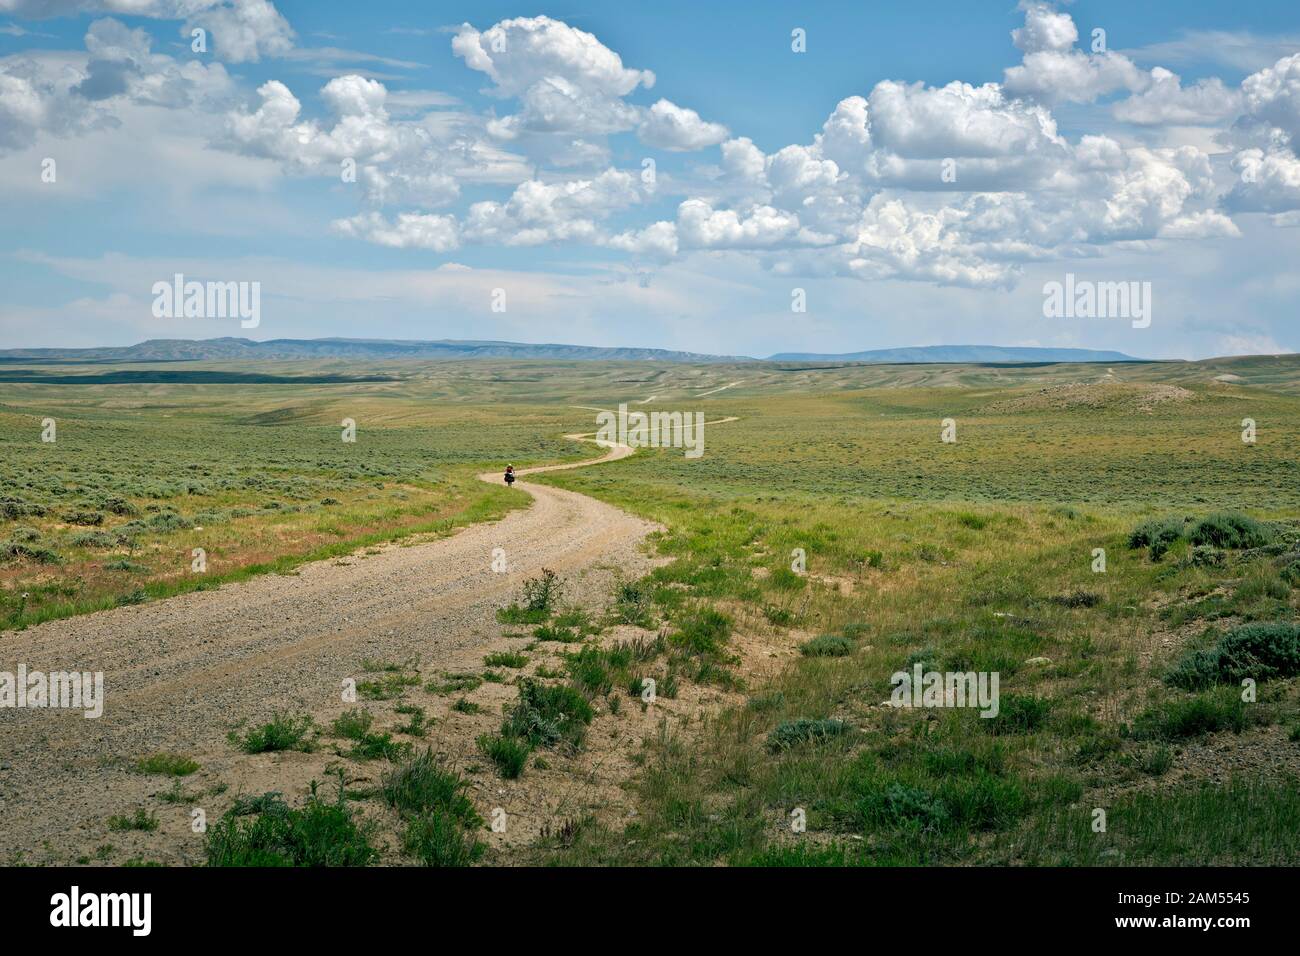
205, 780, 378, 866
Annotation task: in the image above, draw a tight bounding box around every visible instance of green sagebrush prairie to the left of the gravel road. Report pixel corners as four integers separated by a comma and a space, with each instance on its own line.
0, 384, 579, 628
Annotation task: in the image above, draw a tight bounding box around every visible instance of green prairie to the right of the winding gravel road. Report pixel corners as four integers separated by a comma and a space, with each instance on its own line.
540, 367, 1300, 865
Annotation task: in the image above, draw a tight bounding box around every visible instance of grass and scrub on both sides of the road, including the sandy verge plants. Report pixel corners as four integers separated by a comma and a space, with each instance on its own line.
0, 360, 1300, 866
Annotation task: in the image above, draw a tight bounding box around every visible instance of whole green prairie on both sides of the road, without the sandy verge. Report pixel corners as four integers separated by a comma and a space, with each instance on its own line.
0, 356, 1300, 865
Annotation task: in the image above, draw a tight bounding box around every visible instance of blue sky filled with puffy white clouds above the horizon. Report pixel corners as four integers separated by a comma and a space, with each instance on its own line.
0, 0, 1300, 358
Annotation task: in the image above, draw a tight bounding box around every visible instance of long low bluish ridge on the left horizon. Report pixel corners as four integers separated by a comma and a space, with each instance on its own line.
0, 338, 753, 364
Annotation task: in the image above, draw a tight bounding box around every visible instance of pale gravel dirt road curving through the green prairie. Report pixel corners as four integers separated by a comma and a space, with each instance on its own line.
0, 436, 654, 864
